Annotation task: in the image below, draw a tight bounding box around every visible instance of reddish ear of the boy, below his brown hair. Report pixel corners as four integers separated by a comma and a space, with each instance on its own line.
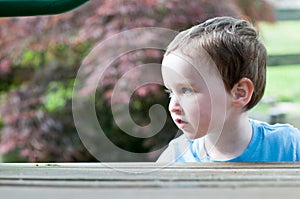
231, 77, 254, 108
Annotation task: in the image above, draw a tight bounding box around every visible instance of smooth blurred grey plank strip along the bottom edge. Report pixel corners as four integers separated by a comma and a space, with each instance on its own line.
0, 187, 300, 199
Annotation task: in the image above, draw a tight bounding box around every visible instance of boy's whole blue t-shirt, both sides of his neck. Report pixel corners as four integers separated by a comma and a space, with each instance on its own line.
157, 120, 300, 162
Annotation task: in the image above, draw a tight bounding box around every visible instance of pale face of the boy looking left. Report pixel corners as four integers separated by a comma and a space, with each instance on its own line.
162, 53, 229, 139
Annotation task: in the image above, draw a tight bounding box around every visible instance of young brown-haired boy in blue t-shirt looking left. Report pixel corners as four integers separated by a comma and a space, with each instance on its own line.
158, 17, 300, 162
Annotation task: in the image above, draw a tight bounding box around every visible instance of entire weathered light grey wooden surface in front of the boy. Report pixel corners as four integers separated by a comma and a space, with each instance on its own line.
0, 163, 300, 199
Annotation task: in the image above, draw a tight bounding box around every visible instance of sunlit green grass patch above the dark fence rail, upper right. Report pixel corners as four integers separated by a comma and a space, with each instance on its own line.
259, 20, 300, 55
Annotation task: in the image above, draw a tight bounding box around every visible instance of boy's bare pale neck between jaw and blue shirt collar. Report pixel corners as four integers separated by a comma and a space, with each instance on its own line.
203, 112, 252, 161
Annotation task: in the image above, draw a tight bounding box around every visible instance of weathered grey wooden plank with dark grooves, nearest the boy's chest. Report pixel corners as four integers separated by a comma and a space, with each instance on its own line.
0, 163, 300, 187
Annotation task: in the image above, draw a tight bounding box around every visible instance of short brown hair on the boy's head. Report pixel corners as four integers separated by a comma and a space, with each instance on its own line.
166, 17, 267, 110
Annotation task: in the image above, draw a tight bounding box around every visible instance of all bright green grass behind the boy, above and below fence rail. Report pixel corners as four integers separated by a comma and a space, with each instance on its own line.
250, 20, 300, 123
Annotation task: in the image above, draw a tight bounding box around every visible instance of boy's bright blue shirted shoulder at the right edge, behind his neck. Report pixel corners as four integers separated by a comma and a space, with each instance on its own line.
233, 120, 300, 162
